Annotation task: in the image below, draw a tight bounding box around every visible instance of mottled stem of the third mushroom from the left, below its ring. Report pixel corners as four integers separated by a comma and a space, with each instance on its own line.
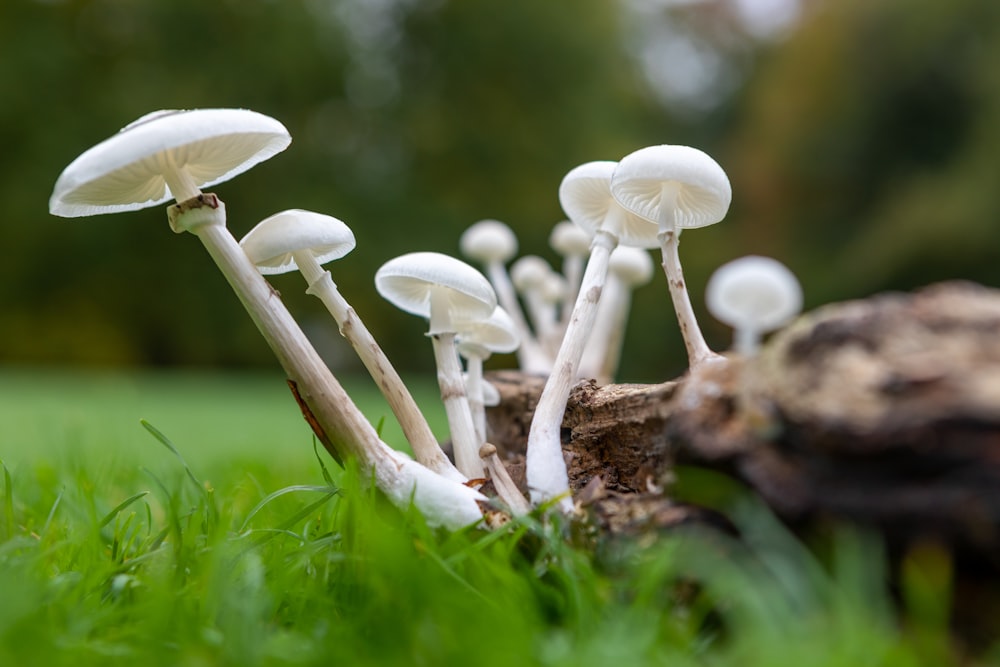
429, 328, 483, 479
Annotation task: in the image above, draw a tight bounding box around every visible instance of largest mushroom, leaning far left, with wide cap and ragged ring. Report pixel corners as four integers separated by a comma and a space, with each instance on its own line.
49, 109, 484, 528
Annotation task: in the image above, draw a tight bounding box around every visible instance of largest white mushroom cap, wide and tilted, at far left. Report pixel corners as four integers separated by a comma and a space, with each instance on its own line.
49, 109, 292, 218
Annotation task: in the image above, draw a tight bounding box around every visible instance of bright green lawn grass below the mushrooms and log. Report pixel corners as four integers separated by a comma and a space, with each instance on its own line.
0, 371, 976, 667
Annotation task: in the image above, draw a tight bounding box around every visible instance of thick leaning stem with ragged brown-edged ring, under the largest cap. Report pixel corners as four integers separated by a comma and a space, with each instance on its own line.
167, 194, 483, 529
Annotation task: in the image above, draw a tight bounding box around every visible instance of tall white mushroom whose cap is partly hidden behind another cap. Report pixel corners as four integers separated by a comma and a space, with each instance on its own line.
525, 161, 657, 511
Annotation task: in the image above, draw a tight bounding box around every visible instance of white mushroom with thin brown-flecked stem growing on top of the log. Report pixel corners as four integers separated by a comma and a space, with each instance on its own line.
611, 145, 732, 367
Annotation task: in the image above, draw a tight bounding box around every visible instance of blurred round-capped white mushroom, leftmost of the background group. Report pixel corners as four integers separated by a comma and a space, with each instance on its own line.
459, 220, 552, 374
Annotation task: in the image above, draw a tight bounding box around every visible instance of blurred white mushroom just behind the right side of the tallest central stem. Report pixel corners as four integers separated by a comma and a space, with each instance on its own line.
579, 246, 653, 384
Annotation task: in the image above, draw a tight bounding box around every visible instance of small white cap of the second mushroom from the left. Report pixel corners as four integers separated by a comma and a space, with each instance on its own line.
240, 208, 355, 275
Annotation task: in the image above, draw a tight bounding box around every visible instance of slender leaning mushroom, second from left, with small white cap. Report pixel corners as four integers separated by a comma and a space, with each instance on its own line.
240, 209, 465, 482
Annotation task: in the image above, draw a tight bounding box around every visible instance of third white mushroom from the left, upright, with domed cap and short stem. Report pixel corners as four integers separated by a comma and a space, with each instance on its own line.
375, 252, 497, 479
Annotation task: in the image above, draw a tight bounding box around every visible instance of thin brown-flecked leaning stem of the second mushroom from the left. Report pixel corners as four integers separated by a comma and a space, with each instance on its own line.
293, 252, 466, 482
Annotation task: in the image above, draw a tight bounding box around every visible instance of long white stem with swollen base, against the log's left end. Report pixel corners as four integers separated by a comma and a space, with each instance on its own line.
525, 229, 618, 512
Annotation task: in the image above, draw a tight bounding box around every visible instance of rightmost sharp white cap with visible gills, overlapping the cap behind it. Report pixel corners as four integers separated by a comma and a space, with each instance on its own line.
611, 145, 733, 229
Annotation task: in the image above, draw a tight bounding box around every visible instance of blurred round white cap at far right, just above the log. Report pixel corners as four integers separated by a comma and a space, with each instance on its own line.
705, 255, 802, 332
